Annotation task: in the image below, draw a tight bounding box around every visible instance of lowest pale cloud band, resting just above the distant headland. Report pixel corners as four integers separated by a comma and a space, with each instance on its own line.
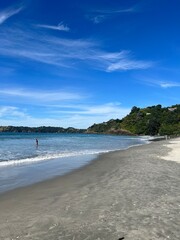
0, 103, 130, 128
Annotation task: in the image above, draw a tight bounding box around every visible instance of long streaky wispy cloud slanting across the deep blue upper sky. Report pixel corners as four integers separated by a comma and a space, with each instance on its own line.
0, 26, 152, 72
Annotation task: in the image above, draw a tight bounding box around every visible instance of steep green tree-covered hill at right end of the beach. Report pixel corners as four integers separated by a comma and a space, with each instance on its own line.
87, 105, 180, 136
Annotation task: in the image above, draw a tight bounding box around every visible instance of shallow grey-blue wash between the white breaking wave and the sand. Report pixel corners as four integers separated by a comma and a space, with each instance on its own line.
0, 140, 150, 194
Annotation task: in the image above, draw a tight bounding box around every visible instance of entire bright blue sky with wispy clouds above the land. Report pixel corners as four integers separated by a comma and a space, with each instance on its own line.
0, 0, 180, 128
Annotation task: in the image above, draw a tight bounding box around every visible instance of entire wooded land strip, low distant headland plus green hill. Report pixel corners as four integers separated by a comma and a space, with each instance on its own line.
0, 104, 180, 136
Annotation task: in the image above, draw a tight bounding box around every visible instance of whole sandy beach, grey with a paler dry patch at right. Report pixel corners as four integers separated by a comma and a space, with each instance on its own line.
0, 138, 180, 240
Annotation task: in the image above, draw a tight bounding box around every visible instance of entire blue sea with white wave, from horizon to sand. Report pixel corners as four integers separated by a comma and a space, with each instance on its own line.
0, 133, 148, 192
